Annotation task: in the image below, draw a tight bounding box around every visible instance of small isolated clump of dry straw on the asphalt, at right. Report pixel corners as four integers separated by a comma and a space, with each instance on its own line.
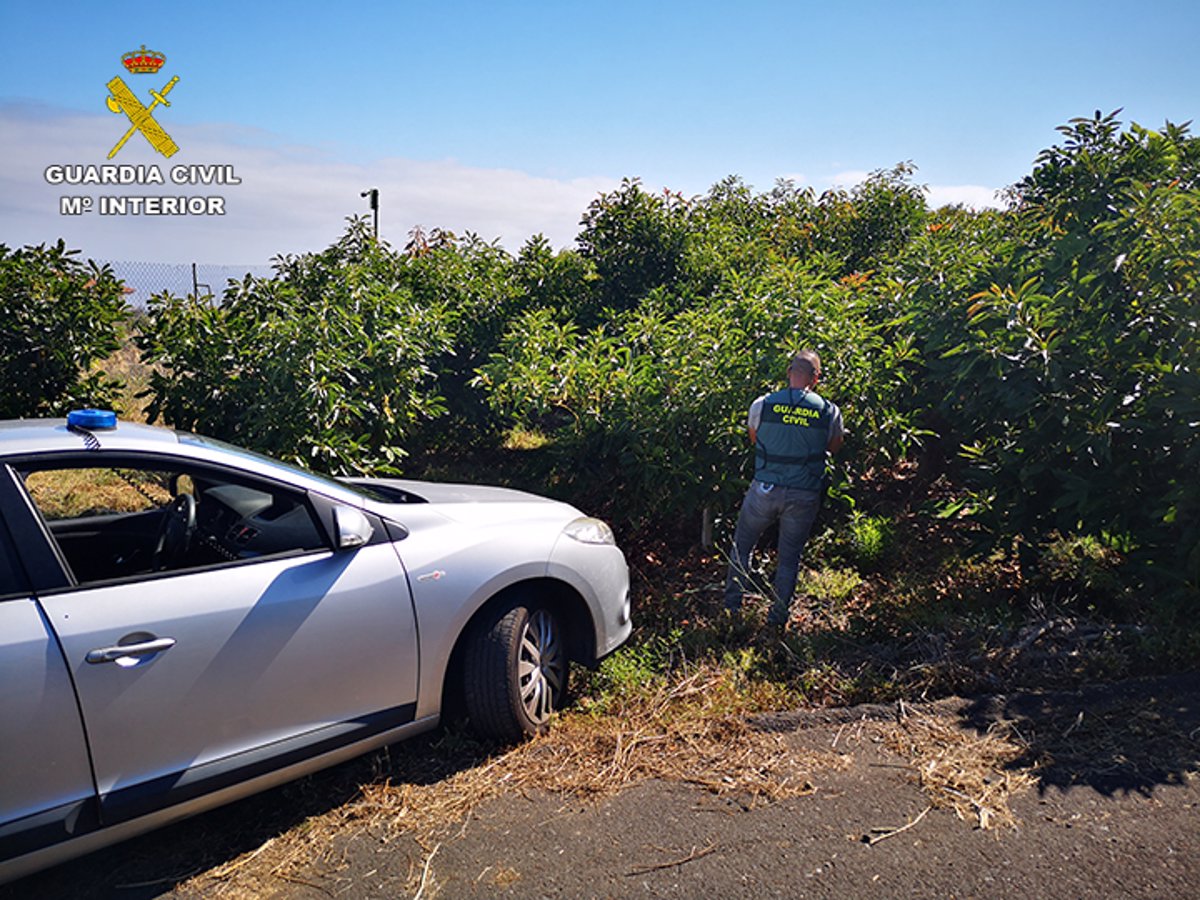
886, 707, 1037, 829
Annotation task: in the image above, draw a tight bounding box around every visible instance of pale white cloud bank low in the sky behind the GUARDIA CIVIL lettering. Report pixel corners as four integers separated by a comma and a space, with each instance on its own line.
0, 104, 617, 265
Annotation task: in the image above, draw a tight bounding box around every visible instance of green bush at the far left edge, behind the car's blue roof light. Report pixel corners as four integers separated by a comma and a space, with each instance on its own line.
0, 240, 130, 419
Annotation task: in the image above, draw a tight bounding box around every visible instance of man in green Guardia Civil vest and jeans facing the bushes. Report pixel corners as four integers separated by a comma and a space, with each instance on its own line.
725, 350, 845, 628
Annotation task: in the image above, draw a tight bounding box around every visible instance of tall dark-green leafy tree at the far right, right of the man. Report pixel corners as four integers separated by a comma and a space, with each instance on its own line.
905, 114, 1200, 592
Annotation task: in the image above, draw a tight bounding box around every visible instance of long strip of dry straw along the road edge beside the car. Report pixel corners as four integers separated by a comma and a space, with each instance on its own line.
180, 666, 845, 898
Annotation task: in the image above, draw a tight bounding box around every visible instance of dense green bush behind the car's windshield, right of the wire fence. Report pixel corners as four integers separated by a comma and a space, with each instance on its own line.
139, 222, 450, 474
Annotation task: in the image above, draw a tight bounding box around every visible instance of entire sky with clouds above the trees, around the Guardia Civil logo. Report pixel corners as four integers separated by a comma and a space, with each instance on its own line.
0, 0, 1200, 264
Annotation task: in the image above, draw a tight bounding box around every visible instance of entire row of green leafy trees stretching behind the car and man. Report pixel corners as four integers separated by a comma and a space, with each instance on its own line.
14, 114, 1200, 607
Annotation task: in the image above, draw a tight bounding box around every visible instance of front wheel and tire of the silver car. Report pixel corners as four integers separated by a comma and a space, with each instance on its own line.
463, 604, 570, 742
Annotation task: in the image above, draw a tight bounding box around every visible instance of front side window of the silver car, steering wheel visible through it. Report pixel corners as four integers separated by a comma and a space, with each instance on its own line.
22, 466, 328, 584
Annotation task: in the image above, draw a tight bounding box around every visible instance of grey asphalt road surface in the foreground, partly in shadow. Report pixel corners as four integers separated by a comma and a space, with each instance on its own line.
288, 677, 1200, 900
